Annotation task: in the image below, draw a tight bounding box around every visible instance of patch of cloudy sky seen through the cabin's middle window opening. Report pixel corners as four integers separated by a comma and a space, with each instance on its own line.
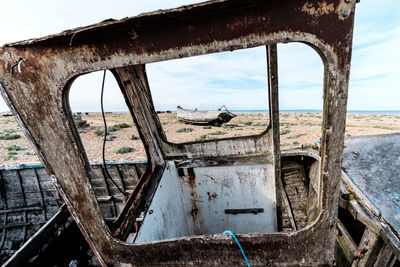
147, 47, 268, 110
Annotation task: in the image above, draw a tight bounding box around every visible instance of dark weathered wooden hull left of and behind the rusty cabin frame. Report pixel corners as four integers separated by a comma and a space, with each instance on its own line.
0, 162, 147, 266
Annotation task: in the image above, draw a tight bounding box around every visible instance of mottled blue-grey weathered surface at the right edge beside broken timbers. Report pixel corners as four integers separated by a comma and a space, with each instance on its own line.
343, 134, 400, 235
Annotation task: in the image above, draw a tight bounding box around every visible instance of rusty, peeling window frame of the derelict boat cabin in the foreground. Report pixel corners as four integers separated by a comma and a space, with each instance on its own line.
0, 0, 362, 266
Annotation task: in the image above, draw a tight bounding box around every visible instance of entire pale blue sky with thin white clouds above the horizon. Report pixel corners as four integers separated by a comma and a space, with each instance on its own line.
0, 0, 400, 112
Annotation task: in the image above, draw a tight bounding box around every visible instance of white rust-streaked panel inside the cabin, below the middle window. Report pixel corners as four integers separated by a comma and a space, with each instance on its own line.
135, 159, 277, 243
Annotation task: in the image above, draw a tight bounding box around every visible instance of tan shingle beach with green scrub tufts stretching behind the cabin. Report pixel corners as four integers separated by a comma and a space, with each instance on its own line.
0, 113, 400, 165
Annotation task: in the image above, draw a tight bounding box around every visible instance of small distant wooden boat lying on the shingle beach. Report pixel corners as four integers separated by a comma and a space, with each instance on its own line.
176, 105, 236, 126
